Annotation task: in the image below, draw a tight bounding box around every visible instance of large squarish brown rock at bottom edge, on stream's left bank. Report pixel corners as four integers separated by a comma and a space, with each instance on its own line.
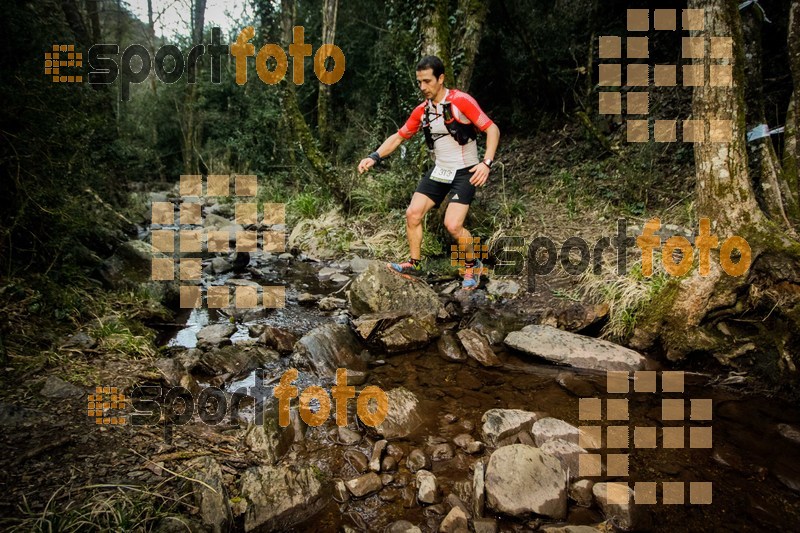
241, 465, 330, 531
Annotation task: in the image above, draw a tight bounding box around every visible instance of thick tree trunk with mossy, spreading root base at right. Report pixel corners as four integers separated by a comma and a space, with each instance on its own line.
632, 0, 800, 379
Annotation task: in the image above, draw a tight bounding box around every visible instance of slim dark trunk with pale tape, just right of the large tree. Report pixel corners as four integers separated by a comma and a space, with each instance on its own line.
741, 8, 791, 229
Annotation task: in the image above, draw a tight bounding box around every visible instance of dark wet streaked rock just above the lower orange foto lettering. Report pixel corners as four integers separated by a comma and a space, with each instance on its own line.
295, 324, 366, 376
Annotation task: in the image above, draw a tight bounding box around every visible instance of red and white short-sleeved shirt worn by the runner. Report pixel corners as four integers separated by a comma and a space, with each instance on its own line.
397, 89, 494, 169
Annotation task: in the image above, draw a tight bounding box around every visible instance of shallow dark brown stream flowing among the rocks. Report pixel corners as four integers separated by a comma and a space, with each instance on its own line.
153, 246, 800, 531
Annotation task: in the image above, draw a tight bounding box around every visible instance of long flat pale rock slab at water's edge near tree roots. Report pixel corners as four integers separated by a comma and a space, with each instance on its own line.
503, 325, 645, 370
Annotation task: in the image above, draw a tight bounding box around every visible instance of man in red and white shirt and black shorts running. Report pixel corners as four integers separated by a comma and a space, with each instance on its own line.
358, 56, 500, 290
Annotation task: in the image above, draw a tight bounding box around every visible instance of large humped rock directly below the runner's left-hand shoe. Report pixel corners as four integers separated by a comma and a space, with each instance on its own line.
348, 261, 443, 316
